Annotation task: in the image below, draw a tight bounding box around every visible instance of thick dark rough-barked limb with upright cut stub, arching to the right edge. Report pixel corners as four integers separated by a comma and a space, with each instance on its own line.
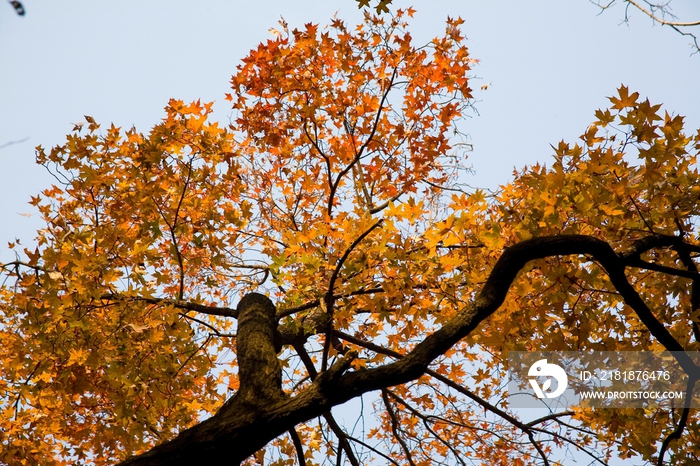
117, 235, 698, 466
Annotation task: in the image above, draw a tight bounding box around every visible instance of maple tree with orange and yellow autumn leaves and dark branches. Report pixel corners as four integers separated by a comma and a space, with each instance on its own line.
0, 9, 700, 465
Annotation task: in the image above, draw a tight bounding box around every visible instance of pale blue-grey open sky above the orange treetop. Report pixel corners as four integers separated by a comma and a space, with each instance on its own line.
0, 0, 700, 462
